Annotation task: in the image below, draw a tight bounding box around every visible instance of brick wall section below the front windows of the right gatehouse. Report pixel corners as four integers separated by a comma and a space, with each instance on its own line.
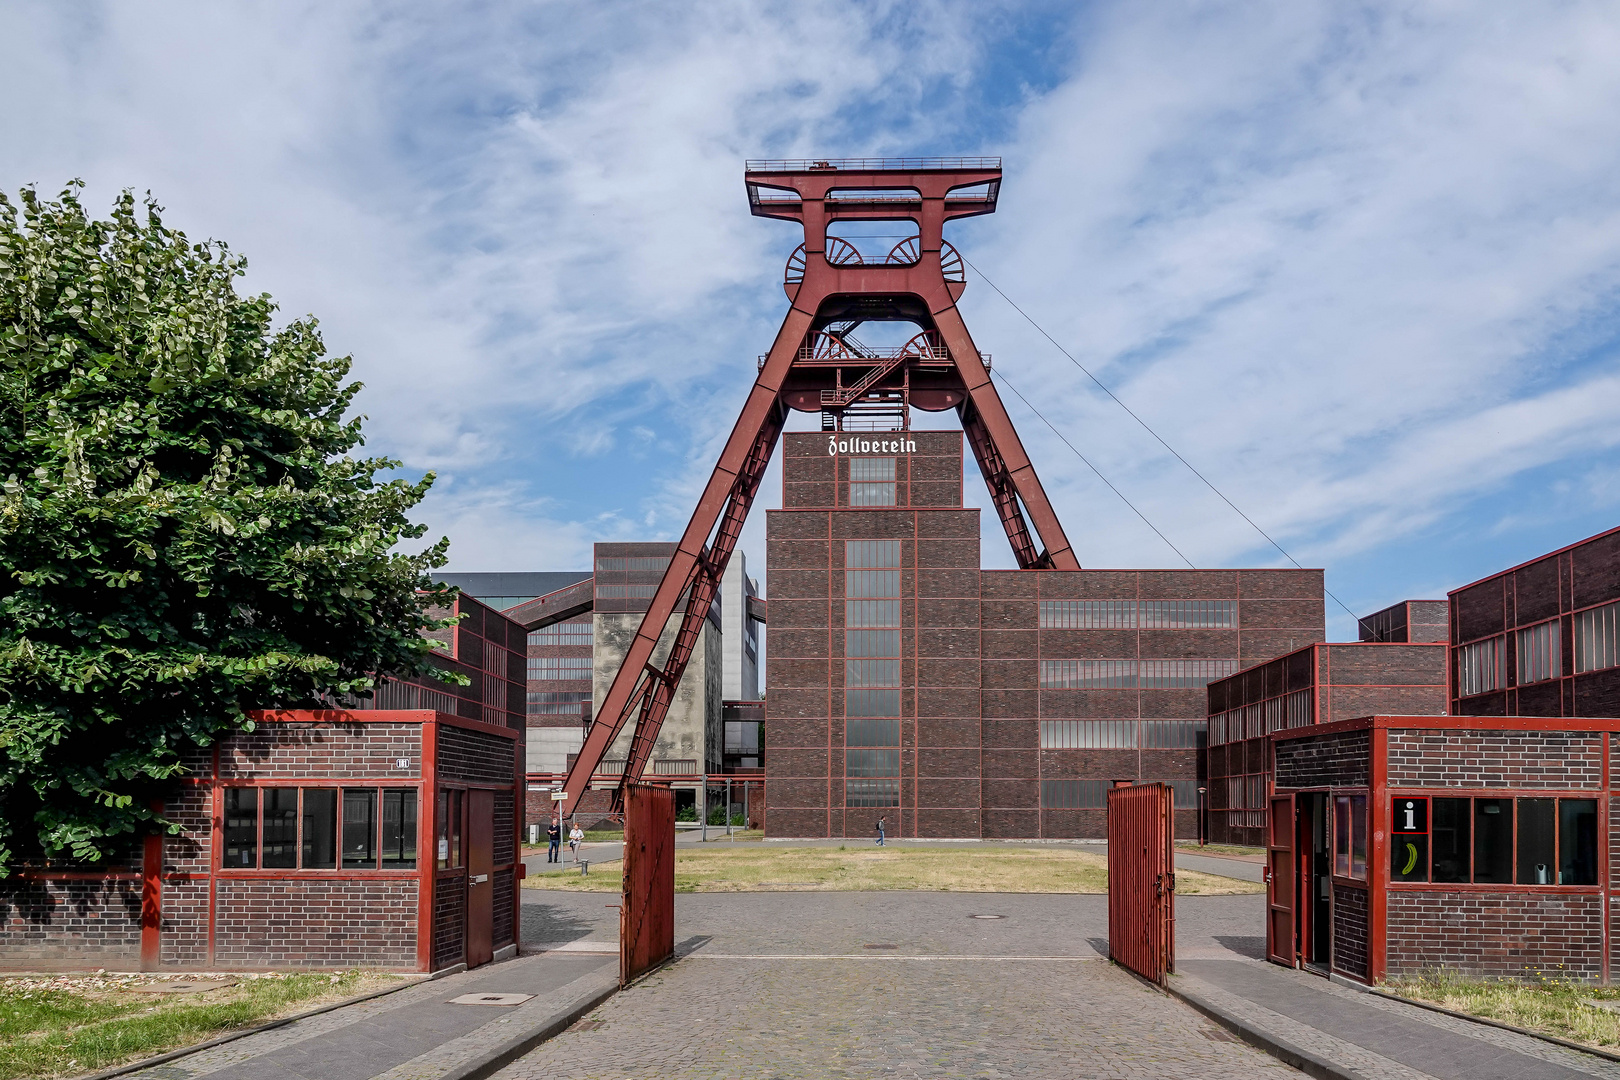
1385, 891, 1602, 980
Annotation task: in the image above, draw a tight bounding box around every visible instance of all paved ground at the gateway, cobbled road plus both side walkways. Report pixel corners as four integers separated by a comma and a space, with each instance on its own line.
126, 889, 1620, 1080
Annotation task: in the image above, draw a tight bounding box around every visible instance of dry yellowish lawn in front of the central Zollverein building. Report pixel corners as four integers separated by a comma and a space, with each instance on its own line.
523, 844, 1264, 895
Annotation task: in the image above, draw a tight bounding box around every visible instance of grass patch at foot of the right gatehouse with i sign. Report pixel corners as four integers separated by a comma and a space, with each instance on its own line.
1383, 972, 1620, 1046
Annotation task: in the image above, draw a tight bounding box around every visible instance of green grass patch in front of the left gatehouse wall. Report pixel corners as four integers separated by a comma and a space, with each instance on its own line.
0, 972, 399, 1080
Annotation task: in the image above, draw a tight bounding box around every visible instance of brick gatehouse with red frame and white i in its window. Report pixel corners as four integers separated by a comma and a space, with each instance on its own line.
1267, 716, 1620, 981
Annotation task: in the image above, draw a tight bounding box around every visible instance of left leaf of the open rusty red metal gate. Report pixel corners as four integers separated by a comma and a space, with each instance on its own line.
619, 784, 676, 986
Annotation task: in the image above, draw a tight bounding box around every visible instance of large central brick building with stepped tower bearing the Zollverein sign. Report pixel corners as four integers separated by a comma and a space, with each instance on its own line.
765, 431, 1324, 837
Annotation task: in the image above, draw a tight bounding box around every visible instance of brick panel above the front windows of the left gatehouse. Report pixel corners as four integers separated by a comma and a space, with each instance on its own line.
219, 722, 421, 780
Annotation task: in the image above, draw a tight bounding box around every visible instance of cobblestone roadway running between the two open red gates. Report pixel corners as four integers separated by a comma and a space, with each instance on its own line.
497, 894, 1299, 1080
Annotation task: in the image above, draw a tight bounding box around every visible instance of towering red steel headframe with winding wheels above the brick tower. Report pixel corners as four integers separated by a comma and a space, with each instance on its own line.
564, 159, 1081, 806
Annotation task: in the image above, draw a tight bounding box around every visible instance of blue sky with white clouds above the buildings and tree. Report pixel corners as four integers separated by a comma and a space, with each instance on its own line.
0, 0, 1620, 638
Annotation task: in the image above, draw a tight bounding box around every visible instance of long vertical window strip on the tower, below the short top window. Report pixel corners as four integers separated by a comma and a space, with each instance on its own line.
844, 540, 901, 806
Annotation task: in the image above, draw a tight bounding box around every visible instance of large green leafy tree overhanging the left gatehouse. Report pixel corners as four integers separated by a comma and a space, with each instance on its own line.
0, 185, 449, 876
